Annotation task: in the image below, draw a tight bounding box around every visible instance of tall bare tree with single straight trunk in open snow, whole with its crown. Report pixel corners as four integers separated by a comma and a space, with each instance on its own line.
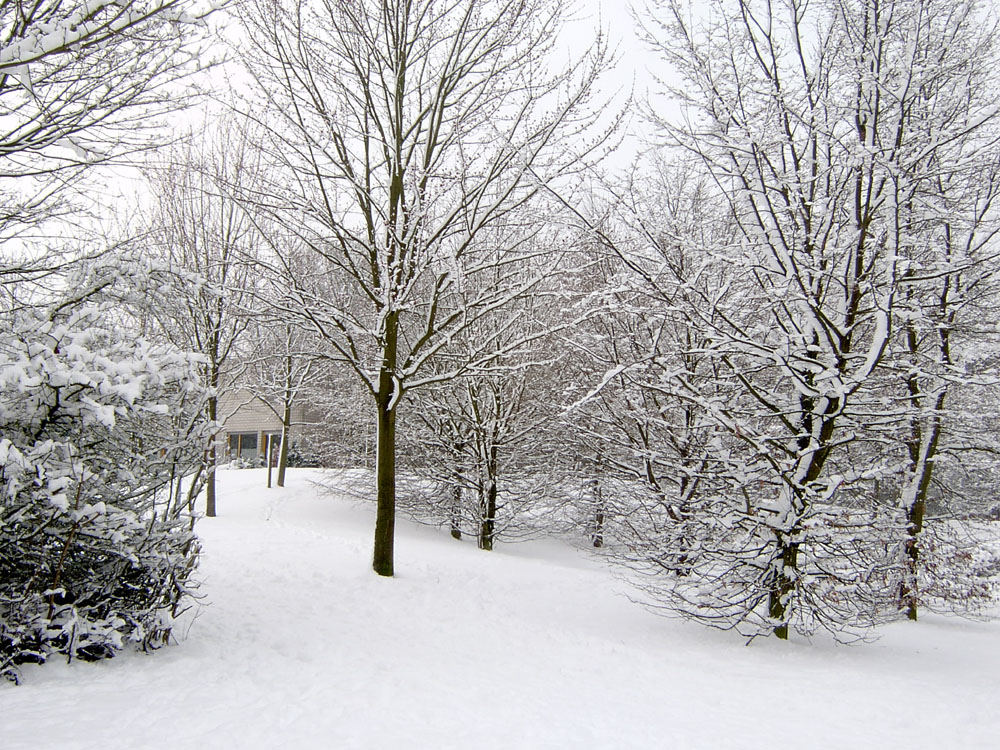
234, 0, 603, 575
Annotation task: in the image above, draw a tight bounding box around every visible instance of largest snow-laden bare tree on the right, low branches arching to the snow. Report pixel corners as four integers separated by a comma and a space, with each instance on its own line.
620, 0, 995, 638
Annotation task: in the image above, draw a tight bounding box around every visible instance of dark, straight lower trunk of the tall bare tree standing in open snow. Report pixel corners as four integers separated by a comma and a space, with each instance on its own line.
372, 313, 399, 576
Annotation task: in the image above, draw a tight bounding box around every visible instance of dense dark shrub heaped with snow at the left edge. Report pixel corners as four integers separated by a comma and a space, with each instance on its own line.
0, 284, 207, 680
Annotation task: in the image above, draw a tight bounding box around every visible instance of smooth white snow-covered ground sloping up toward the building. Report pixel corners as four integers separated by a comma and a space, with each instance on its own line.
0, 470, 1000, 750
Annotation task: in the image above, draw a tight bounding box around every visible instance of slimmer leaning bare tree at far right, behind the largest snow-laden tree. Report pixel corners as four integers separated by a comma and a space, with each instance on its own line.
890, 126, 1000, 620
